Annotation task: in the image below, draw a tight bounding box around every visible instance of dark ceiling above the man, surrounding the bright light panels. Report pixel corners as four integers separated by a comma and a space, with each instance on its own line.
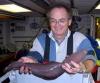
0, 0, 100, 20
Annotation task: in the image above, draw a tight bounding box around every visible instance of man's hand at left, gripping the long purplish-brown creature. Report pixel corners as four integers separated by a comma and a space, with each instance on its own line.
18, 56, 38, 74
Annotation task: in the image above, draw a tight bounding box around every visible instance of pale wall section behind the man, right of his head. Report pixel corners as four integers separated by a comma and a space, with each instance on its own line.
76, 14, 95, 37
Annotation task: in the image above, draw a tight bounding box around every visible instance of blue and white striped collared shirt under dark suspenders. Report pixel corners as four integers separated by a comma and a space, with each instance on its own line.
30, 30, 96, 62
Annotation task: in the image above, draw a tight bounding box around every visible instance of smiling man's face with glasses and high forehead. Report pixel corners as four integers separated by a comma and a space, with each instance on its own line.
49, 8, 71, 36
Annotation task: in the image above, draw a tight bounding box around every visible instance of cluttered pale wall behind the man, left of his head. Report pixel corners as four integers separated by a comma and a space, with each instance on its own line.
3, 16, 47, 49
